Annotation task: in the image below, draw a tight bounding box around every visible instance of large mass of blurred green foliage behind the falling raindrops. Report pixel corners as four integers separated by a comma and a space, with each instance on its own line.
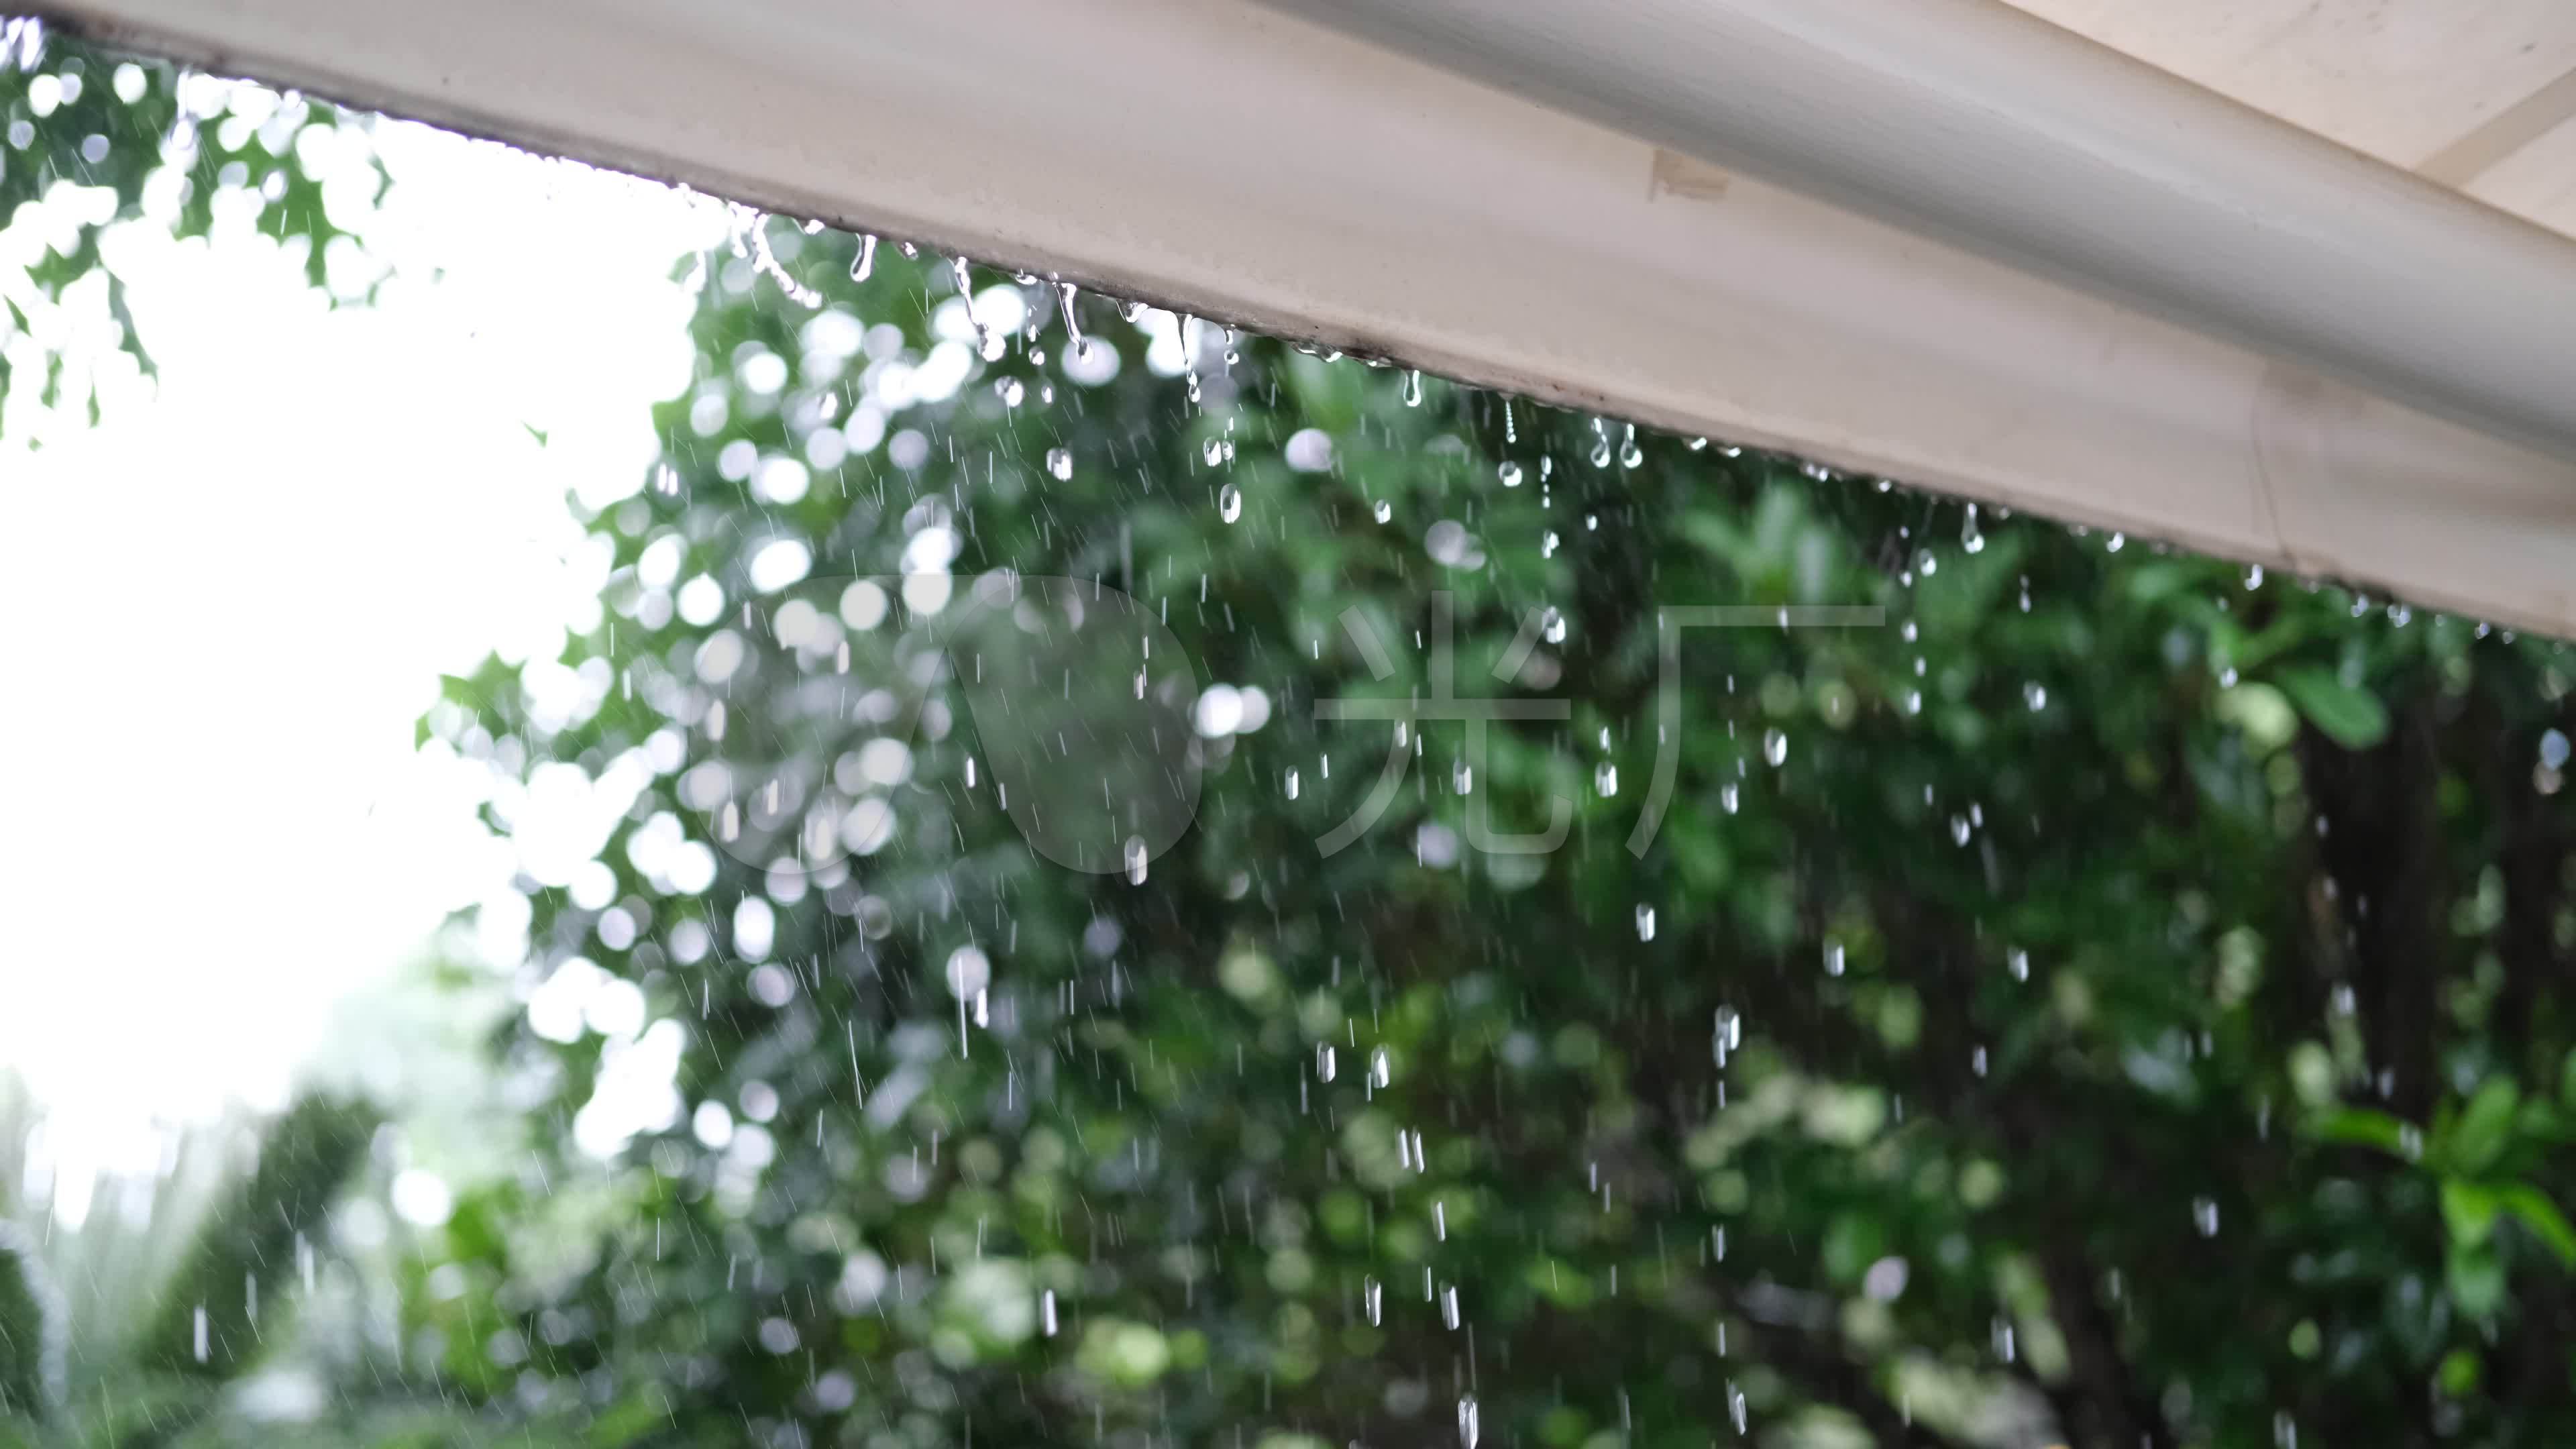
410, 222, 2576, 1449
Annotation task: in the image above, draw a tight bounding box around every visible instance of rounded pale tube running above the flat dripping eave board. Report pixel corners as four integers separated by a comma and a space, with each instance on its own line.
1273, 0, 2576, 456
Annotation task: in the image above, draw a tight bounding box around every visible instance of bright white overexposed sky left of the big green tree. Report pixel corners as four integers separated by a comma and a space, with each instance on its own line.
0, 107, 724, 1144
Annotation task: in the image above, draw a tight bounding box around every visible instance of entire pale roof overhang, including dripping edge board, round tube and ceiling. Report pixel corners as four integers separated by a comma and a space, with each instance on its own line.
39, 0, 2576, 634
